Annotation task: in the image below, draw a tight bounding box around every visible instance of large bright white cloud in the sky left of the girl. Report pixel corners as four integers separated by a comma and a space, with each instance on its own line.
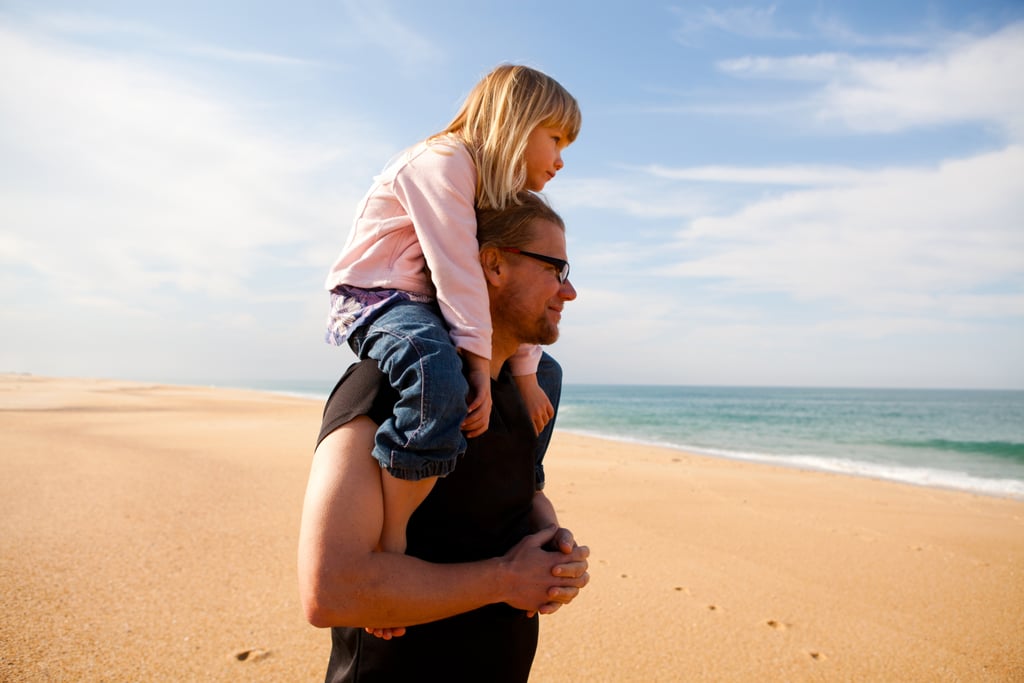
0, 22, 376, 301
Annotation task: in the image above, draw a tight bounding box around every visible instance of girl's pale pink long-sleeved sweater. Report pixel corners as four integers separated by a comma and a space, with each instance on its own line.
326, 136, 541, 375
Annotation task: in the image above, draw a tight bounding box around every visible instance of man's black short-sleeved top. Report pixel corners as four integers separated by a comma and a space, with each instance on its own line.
317, 361, 538, 683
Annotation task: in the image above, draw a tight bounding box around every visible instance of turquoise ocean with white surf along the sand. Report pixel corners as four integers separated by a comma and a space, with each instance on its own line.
253, 383, 1024, 500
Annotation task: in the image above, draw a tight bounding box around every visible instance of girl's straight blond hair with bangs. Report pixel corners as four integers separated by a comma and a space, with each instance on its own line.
431, 65, 581, 209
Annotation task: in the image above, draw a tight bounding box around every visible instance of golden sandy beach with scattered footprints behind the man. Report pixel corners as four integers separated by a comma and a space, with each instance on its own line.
0, 375, 1024, 682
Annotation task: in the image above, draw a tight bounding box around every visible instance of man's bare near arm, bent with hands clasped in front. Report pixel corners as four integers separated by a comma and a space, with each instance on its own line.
298, 417, 588, 628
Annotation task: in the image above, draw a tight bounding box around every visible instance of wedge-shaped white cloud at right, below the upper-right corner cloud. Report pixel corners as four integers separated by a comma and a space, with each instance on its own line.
666, 146, 1024, 315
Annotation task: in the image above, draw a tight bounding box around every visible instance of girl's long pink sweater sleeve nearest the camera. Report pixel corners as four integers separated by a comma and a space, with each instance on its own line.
394, 142, 490, 358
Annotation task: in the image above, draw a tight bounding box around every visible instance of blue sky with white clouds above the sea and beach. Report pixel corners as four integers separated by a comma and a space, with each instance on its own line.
0, 0, 1024, 389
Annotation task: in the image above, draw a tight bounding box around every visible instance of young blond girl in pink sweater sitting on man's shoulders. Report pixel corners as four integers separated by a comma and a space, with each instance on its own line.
327, 65, 581, 552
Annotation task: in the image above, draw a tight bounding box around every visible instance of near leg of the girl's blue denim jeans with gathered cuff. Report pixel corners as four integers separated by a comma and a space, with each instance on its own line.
349, 301, 469, 481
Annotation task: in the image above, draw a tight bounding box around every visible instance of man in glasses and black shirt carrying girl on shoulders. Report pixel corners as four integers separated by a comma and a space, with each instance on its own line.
299, 194, 589, 682
